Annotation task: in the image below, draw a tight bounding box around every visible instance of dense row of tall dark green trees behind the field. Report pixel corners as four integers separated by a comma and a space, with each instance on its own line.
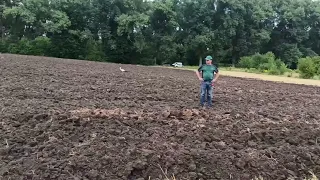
0, 0, 320, 68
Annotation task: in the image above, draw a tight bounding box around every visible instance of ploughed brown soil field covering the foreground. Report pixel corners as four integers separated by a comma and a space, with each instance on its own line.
0, 54, 320, 180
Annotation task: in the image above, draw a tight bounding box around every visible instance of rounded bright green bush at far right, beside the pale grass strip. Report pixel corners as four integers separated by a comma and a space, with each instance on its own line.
298, 57, 317, 79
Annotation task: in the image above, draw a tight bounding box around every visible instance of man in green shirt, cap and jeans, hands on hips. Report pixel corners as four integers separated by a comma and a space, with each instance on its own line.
196, 56, 219, 107
